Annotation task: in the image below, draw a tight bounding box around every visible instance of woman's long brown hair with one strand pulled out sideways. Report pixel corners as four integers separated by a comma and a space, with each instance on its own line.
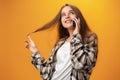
34, 4, 91, 40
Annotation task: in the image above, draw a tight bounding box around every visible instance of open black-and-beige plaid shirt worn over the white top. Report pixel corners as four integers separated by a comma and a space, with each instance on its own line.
32, 33, 98, 80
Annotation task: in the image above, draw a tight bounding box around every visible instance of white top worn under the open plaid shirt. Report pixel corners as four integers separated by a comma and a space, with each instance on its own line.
51, 42, 72, 80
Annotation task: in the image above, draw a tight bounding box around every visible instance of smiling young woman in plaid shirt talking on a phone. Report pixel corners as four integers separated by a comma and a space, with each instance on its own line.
25, 4, 98, 80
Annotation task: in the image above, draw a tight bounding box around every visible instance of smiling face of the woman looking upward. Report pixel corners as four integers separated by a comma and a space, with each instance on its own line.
61, 6, 76, 29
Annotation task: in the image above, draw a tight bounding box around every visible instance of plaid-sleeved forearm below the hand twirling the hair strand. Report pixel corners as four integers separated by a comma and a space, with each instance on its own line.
32, 52, 53, 80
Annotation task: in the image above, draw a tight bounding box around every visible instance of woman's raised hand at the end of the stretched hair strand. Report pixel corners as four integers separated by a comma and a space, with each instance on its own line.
25, 35, 38, 53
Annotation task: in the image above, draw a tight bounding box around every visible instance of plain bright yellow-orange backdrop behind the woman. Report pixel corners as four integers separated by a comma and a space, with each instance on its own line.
0, 0, 120, 80
